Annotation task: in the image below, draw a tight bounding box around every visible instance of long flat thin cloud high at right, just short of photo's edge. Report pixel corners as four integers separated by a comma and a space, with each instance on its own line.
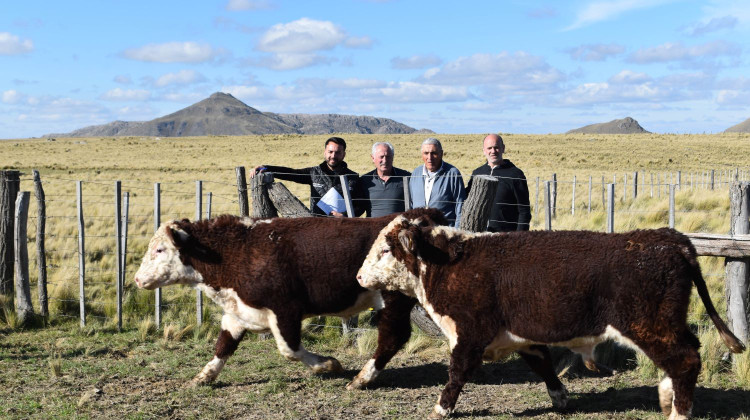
628, 41, 741, 64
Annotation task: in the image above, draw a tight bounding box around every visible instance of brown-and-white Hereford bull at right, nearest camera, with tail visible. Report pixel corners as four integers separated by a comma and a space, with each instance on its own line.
357, 217, 744, 419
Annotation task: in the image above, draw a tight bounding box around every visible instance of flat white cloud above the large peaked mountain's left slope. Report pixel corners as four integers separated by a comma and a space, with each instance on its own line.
122, 41, 219, 63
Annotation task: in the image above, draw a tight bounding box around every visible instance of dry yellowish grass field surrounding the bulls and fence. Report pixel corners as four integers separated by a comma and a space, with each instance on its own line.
0, 134, 750, 419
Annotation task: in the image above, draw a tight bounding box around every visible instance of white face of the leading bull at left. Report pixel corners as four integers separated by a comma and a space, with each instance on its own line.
134, 222, 203, 290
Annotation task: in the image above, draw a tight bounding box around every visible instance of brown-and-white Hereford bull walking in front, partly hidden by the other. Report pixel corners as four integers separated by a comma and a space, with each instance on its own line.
135, 209, 447, 388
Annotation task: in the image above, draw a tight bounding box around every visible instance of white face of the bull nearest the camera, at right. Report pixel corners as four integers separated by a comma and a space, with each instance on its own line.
357, 216, 420, 297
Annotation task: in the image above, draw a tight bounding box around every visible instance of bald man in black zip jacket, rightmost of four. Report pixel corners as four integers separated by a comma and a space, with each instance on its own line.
466, 134, 531, 232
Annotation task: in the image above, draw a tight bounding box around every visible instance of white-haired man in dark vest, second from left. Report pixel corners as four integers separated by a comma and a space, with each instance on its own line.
354, 142, 409, 217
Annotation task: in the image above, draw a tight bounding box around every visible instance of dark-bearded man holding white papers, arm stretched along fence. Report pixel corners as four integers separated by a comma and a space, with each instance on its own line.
250, 137, 358, 217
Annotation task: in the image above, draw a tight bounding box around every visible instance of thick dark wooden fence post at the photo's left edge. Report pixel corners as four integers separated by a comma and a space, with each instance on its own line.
0, 171, 21, 300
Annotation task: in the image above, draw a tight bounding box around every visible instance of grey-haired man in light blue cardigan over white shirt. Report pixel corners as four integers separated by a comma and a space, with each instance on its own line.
409, 137, 466, 227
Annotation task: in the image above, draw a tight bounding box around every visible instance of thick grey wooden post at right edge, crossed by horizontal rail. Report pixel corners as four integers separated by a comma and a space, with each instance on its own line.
725, 182, 750, 344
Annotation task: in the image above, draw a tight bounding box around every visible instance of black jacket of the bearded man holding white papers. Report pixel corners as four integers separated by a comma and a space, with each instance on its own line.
264, 162, 359, 216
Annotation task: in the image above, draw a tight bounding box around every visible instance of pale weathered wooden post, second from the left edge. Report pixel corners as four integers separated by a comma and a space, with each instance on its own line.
13, 191, 34, 325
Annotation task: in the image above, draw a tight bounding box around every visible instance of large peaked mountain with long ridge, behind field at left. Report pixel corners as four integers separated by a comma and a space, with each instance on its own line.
43, 92, 424, 137
